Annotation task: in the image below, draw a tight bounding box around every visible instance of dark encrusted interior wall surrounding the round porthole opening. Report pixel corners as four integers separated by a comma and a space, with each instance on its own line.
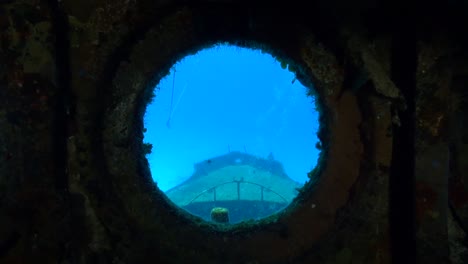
0, 0, 468, 263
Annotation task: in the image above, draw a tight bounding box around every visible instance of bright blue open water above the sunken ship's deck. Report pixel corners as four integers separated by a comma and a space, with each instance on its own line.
144, 45, 319, 191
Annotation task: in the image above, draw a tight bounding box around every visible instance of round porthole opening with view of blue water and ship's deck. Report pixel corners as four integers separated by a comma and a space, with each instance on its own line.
144, 44, 320, 223
